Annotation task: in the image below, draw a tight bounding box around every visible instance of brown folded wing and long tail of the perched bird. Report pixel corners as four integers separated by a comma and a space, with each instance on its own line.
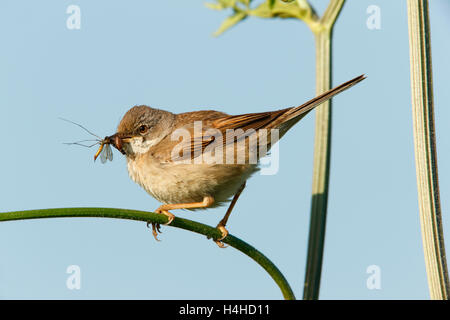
158, 75, 365, 161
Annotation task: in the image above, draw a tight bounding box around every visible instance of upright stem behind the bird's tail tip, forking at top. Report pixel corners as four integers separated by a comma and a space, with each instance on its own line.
303, 0, 345, 300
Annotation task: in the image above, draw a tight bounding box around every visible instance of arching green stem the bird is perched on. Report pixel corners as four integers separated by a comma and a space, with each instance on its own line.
0, 208, 295, 300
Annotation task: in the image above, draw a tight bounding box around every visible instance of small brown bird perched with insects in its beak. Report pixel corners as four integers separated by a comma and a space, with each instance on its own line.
97, 75, 365, 247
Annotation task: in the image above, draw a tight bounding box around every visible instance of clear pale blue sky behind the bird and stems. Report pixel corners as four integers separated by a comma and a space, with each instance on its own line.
0, 0, 450, 299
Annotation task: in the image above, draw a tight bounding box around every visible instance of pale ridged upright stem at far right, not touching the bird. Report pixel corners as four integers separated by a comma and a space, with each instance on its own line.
407, 0, 450, 300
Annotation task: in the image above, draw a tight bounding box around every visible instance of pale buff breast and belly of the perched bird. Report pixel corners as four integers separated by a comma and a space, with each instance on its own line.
123, 122, 264, 207
